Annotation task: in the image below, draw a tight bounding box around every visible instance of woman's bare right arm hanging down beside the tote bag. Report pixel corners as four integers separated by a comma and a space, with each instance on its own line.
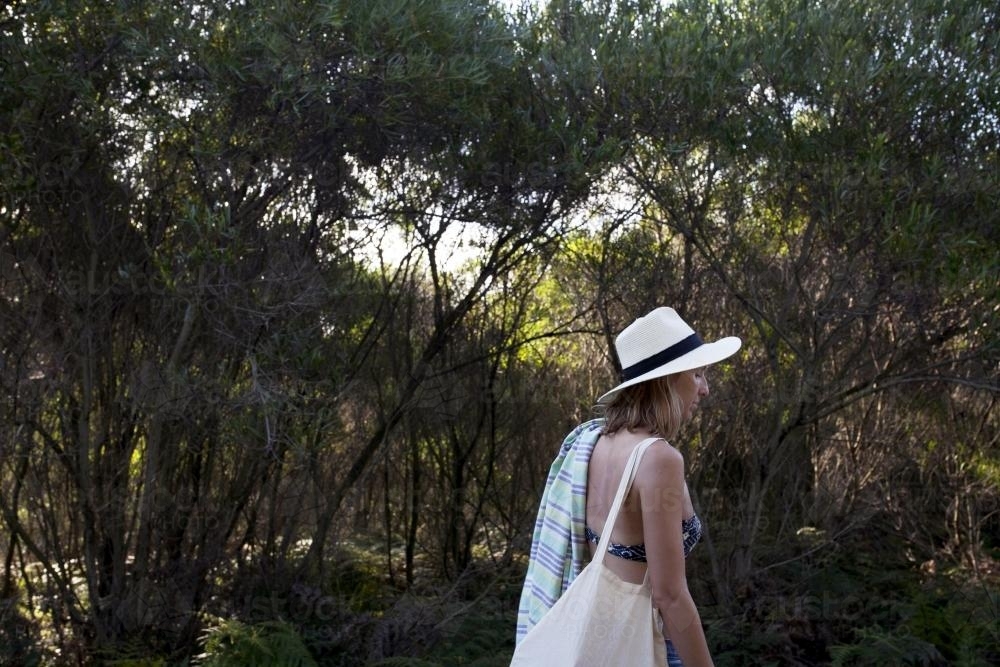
634, 442, 713, 667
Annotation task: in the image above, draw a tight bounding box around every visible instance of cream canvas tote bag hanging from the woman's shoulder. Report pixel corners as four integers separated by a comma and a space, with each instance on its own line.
510, 438, 667, 667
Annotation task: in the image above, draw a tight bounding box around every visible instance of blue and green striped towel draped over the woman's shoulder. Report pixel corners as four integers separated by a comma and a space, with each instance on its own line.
515, 419, 604, 643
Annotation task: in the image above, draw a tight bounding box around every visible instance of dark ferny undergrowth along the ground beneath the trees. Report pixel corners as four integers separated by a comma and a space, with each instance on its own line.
0, 535, 1000, 667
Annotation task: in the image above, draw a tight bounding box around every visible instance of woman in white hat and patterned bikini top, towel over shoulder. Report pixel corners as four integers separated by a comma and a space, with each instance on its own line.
517, 308, 741, 667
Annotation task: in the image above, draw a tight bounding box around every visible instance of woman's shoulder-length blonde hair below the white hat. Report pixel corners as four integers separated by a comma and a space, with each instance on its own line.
598, 373, 684, 440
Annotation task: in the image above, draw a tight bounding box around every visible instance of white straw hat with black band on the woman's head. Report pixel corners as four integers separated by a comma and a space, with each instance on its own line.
597, 307, 743, 403
